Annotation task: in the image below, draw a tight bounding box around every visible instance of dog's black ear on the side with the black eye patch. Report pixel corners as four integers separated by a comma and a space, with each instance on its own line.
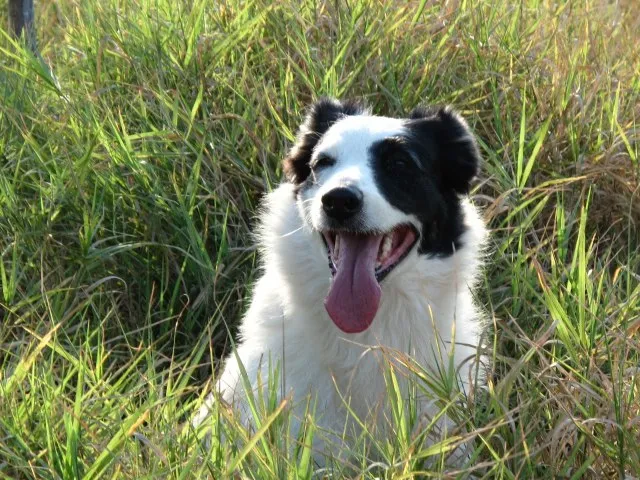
409, 107, 480, 194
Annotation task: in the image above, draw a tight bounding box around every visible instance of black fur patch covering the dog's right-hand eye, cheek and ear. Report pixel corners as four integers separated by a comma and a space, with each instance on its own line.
370, 109, 480, 256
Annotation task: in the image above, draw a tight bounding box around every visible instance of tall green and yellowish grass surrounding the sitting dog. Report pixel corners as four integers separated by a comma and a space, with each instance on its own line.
0, 0, 640, 479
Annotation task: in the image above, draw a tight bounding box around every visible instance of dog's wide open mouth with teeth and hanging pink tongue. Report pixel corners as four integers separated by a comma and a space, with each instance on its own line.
322, 225, 418, 333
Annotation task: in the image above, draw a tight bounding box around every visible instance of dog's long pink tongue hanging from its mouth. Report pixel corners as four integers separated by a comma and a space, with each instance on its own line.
324, 233, 381, 333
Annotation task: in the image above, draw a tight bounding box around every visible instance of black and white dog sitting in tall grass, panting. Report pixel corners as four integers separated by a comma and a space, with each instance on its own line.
193, 98, 487, 462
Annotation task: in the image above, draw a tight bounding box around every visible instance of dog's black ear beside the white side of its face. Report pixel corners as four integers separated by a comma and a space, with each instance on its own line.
283, 98, 365, 184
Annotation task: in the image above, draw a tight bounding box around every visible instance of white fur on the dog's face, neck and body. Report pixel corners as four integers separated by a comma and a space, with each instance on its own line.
194, 115, 486, 464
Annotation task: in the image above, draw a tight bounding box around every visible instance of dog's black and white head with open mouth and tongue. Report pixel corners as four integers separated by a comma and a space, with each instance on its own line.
284, 99, 479, 333
